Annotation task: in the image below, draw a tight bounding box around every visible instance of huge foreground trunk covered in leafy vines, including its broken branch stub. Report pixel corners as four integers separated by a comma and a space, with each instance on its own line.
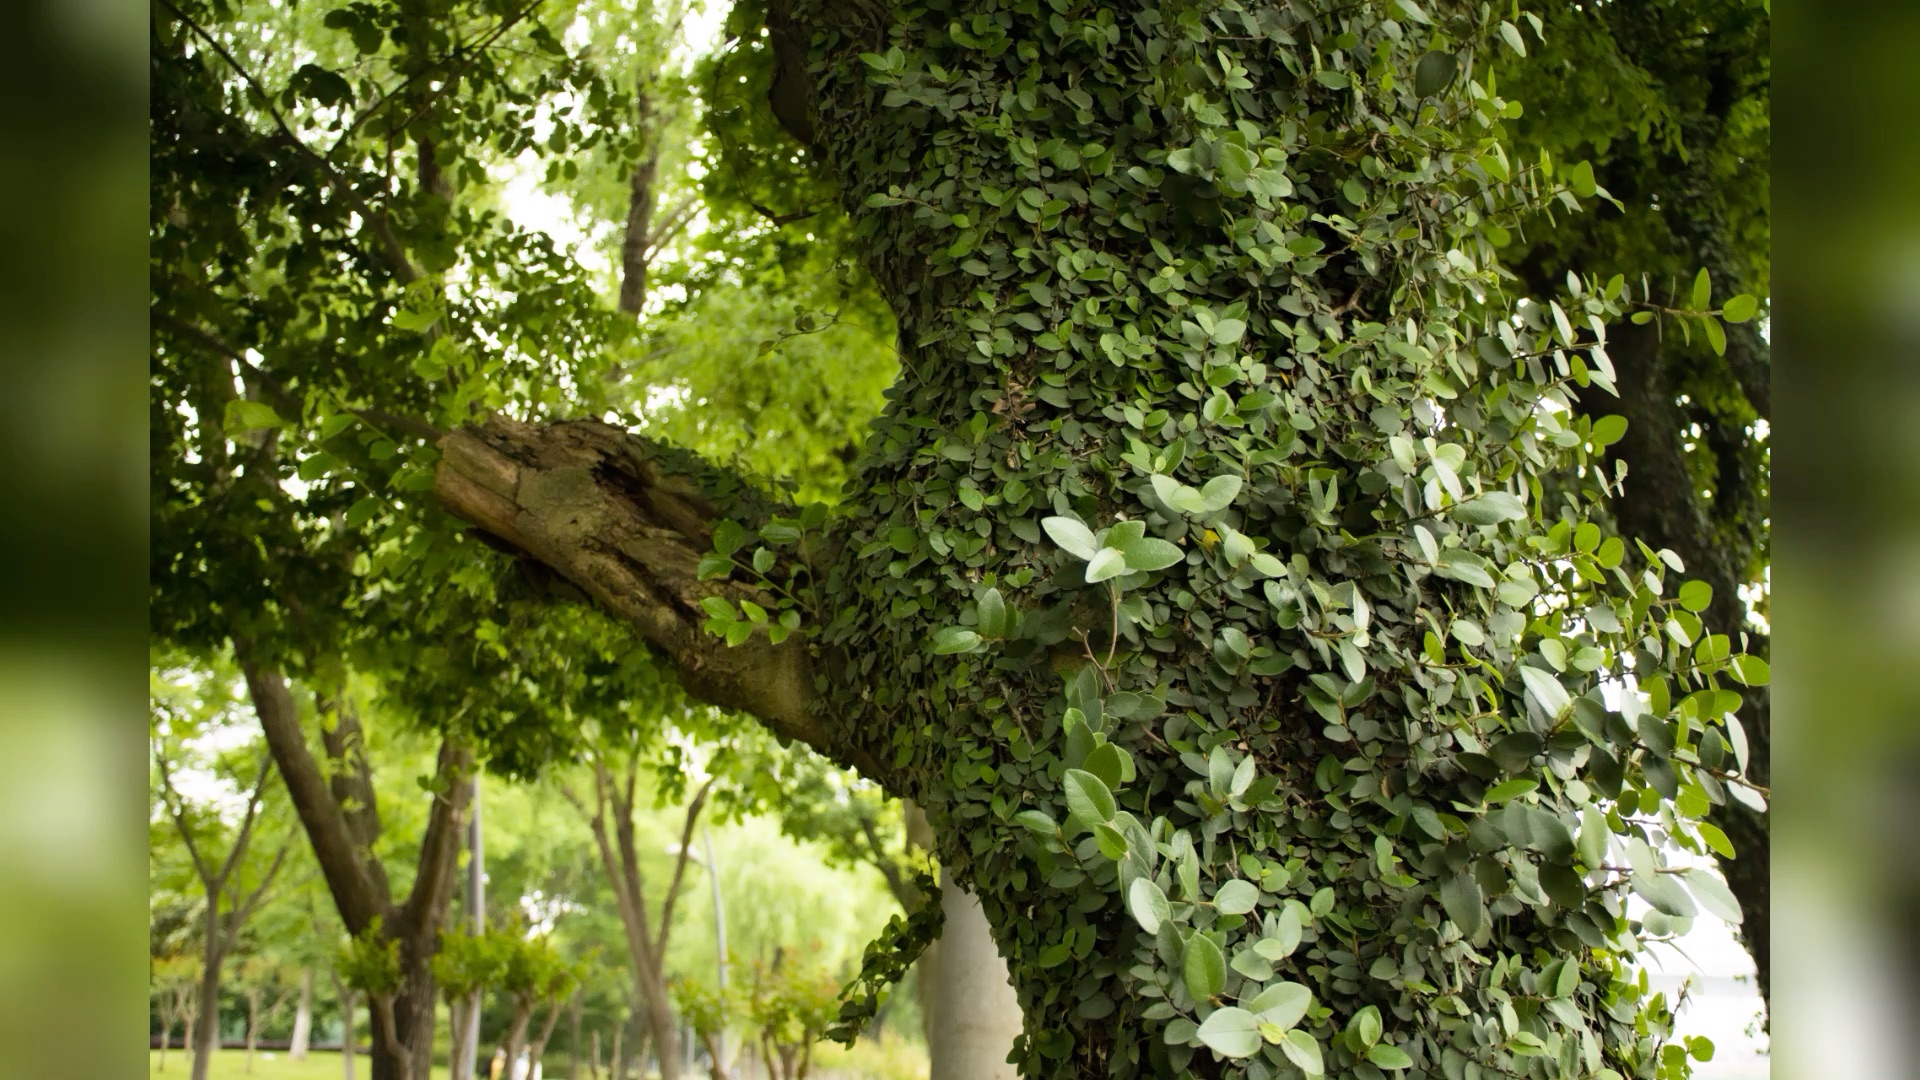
436, 0, 1764, 1080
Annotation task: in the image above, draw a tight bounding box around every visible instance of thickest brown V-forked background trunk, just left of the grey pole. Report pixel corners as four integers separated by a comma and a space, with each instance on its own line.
234, 657, 472, 1080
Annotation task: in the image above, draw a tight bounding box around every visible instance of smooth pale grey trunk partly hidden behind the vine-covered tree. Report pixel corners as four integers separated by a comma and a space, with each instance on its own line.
922, 871, 1020, 1080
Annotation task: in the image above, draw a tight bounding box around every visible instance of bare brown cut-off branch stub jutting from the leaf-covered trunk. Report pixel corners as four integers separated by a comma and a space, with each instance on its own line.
434, 417, 887, 778
